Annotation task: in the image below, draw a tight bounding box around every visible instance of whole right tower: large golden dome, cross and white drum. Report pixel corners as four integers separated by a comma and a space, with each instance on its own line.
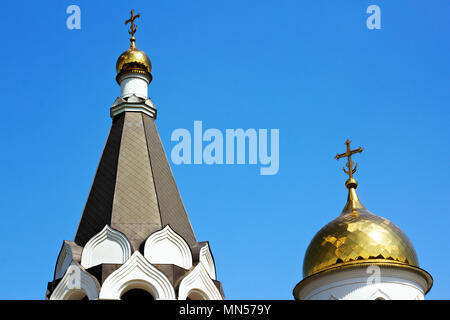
294, 140, 433, 300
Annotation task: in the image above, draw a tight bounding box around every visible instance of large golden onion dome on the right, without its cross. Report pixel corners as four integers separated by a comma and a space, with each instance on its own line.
303, 178, 419, 278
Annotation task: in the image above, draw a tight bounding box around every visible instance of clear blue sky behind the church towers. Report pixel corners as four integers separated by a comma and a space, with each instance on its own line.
0, 0, 450, 299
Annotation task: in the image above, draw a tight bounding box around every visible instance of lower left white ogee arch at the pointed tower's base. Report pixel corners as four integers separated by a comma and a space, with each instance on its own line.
50, 262, 100, 300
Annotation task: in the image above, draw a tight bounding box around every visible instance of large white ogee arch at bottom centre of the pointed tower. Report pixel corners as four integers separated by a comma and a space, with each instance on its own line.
100, 251, 175, 300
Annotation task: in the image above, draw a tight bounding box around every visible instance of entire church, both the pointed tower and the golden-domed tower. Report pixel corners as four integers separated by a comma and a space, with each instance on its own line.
46, 10, 433, 300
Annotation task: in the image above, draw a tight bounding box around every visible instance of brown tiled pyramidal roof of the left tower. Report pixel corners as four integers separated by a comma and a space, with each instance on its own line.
75, 95, 197, 250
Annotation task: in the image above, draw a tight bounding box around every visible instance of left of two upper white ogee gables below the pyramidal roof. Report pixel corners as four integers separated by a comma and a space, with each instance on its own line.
81, 225, 131, 269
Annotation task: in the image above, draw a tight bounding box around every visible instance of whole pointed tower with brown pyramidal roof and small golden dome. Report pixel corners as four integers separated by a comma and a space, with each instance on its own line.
46, 11, 224, 300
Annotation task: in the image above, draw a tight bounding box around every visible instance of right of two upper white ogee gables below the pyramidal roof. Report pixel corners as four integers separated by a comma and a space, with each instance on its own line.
144, 225, 192, 269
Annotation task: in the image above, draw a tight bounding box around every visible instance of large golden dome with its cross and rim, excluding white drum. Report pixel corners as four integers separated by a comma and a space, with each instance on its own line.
293, 139, 433, 299
